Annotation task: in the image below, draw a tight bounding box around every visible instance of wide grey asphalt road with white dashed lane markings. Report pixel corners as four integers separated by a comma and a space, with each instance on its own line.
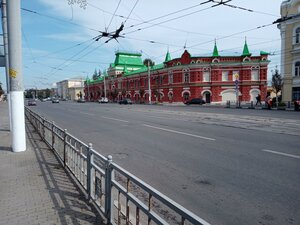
31, 102, 300, 225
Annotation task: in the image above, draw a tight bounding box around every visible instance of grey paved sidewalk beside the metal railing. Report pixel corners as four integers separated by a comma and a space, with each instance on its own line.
0, 102, 103, 225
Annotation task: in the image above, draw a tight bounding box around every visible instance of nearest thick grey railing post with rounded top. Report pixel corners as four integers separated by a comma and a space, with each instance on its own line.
105, 155, 113, 224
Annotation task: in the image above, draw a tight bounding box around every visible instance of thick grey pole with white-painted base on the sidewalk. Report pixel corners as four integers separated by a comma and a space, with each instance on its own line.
7, 0, 26, 152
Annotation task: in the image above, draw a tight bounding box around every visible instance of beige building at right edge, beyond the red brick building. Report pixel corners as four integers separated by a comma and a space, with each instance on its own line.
278, 0, 300, 101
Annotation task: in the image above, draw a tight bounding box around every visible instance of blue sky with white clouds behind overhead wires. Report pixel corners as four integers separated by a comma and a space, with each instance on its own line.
0, 0, 282, 89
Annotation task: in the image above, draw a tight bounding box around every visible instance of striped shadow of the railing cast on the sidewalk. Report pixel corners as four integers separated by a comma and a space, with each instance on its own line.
26, 121, 104, 225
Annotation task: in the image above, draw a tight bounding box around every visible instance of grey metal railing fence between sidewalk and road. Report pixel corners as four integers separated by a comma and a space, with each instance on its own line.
25, 107, 209, 225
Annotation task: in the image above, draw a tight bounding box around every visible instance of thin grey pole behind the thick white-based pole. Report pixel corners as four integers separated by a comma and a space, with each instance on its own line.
1, 0, 12, 131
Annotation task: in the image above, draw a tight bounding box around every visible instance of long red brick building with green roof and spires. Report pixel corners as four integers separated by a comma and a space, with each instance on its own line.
85, 42, 270, 103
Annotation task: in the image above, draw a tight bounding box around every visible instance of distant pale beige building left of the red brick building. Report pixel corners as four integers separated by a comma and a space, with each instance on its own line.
56, 78, 84, 100
